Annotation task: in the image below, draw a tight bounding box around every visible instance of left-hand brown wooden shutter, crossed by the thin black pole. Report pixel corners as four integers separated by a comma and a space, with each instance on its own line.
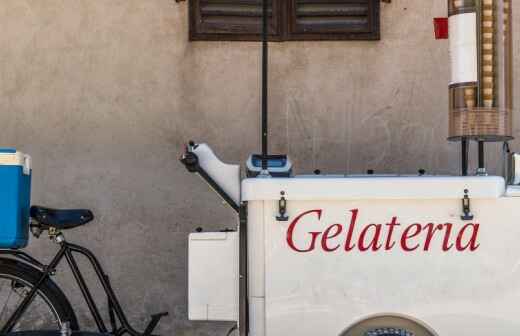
190, 0, 280, 41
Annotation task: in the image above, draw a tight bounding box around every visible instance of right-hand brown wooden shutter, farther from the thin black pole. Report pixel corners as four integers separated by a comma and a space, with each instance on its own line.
287, 0, 380, 40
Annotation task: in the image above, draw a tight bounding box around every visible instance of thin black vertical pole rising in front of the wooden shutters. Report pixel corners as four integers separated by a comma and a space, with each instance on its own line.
262, 0, 269, 170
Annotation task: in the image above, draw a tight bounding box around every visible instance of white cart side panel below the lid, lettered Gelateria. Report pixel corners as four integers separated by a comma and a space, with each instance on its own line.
262, 197, 520, 336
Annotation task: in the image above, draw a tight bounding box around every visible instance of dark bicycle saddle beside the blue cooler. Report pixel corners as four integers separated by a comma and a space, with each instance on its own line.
31, 206, 94, 230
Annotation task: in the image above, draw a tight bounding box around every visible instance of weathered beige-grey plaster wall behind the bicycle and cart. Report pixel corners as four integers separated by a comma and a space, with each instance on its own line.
0, 0, 520, 336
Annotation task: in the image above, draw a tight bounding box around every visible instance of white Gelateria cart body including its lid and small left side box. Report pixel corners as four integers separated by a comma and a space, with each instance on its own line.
188, 146, 520, 336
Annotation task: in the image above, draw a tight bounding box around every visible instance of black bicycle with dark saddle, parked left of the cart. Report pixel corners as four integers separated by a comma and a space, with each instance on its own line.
0, 206, 168, 336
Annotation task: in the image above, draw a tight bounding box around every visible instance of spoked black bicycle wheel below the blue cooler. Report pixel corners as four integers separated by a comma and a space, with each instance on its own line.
0, 259, 78, 331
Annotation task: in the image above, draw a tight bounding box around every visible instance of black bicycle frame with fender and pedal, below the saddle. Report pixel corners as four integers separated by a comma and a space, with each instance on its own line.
0, 239, 168, 336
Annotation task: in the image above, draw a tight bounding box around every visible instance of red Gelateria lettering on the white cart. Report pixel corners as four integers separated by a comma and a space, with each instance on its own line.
287, 209, 480, 253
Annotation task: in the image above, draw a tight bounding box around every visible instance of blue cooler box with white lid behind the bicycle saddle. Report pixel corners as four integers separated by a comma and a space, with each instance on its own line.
0, 148, 31, 248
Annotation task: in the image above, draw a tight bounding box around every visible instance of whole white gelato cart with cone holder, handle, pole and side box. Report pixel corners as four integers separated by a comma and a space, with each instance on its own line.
182, 0, 520, 336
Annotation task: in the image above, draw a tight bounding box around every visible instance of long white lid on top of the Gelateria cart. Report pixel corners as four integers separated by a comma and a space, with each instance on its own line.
242, 176, 505, 201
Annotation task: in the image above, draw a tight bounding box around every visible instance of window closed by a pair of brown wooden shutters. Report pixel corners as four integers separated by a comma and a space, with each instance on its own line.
189, 0, 380, 41
